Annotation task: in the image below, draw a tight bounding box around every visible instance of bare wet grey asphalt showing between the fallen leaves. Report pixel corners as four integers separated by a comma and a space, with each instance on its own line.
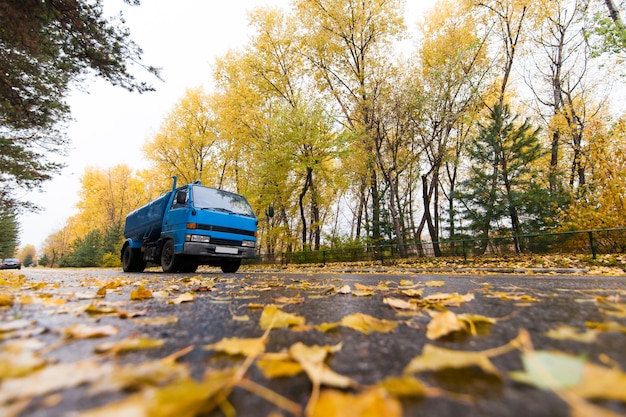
0, 269, 626, 417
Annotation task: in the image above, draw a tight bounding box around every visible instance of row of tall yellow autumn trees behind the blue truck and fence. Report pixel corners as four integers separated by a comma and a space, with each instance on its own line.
39, 0, 626, 263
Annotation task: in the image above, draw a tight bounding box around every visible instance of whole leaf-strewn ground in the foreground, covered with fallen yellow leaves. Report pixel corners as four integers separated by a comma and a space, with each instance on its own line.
0, 271, 626, 417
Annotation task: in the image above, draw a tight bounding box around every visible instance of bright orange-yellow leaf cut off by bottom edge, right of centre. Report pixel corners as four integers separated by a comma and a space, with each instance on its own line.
311, 388, 402, 417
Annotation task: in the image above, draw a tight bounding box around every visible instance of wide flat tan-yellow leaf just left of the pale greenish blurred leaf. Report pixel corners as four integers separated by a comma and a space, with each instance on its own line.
404, 344, 500, 377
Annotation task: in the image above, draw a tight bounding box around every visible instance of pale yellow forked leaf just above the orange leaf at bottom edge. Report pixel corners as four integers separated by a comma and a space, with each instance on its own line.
289, 342, 354, 388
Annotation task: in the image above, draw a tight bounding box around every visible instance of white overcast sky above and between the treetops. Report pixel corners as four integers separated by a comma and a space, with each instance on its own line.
15, 0, 436, 249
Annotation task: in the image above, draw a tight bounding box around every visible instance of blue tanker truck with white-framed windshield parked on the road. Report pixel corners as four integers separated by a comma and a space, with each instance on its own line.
121, 177, 258, 273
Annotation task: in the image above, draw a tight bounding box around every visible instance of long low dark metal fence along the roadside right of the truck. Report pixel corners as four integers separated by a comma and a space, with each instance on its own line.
246, 228, 626, 265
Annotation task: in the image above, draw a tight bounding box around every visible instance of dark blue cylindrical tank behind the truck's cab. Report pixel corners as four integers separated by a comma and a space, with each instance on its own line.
124, 191, 172, 241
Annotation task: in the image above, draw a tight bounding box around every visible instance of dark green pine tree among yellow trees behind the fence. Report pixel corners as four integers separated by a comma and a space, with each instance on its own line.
461, 105, 552, 252
